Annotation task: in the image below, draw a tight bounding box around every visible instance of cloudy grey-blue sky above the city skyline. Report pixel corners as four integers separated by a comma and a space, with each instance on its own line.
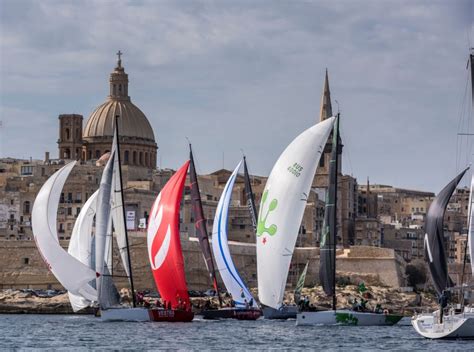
0, 0, 474, 193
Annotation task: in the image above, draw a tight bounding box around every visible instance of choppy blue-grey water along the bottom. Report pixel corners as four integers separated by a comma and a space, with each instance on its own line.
0, 315, 474, 351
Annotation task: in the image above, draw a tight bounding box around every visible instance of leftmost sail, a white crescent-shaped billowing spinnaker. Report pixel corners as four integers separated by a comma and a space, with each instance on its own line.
32, 161, 97, 300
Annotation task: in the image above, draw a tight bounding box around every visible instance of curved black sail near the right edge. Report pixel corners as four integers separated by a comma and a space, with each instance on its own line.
425, 168, 468, 295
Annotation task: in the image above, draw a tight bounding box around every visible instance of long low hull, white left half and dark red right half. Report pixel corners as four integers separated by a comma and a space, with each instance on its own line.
100, 307, 194, 322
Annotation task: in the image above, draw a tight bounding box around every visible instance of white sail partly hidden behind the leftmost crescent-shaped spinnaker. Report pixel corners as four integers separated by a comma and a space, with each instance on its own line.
68, 191, 99, 312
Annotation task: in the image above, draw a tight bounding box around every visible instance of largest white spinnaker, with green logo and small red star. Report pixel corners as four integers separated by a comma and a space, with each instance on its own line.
257, 117, 335, 309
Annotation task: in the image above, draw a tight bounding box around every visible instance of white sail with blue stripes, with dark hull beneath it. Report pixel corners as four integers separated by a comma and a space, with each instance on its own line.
209, 161, 261, 320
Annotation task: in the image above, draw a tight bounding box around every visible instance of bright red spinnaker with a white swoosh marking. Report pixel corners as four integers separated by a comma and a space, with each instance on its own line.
147, 161, 189, 308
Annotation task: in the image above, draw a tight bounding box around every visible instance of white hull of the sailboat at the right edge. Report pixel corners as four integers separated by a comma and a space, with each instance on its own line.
411, 308, 474, 339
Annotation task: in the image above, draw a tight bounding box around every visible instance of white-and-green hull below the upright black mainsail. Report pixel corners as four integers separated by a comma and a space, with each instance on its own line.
296, 309, 402, 326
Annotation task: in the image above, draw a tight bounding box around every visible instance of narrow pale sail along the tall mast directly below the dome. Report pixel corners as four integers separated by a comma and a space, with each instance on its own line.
110, 133, 130, 278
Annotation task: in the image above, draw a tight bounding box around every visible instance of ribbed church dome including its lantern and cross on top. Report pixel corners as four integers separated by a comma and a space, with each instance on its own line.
82, 51, 155, 144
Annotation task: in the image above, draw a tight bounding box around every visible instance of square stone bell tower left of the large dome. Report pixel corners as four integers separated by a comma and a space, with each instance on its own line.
58, 114, 83, 160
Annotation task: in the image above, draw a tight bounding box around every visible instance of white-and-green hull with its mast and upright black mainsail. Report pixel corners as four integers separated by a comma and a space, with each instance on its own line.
296, 114, 403, 326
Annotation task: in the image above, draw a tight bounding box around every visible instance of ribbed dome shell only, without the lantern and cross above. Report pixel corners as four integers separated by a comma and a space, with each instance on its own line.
83, 99, 155, 142
